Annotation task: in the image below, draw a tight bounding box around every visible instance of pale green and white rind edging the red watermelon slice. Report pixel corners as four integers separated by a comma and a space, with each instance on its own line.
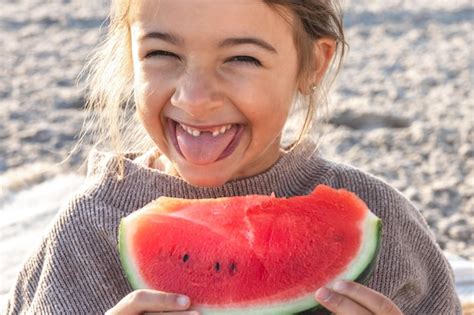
119, 211, 382, 315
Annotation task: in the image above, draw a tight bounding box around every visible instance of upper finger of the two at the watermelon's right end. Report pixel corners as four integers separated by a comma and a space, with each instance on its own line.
333, 281, 402, 315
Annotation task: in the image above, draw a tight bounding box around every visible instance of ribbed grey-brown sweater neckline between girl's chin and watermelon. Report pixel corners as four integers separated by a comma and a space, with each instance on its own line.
87, 140, 325, 208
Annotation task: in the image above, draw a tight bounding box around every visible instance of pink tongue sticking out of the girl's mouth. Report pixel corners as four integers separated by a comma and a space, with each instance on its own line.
176, 124, 237, 165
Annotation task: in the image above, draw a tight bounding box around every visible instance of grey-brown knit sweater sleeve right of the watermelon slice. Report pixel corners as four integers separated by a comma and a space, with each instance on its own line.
362, 181, 461, 315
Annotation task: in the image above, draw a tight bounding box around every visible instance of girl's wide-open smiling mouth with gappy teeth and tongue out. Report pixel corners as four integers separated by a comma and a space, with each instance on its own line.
167, 118, 245, 165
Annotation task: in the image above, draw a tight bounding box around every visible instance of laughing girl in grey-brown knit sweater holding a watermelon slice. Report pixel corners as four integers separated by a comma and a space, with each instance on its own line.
7, 0, 460, 314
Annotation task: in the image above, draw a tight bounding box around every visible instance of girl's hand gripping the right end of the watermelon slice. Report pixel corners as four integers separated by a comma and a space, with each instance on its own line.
315, 281, 403, 315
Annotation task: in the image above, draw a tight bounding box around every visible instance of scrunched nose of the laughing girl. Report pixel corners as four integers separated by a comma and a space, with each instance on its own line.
171, 69, 223, 117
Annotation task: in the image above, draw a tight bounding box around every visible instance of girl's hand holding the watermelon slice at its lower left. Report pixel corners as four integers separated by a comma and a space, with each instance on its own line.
105, 289, 199, 315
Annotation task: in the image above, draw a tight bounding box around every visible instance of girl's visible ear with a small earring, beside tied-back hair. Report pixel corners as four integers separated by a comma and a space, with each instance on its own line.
300, 37, 336, 94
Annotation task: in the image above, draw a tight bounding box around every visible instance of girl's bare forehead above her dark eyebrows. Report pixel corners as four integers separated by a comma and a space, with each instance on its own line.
130, 0, 292, 45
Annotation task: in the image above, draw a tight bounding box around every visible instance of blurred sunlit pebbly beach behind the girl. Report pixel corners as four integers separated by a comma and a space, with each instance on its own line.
0, 0, 474, 312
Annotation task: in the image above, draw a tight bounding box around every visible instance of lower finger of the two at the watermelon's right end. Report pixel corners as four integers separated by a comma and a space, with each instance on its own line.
316, 288, 373, 315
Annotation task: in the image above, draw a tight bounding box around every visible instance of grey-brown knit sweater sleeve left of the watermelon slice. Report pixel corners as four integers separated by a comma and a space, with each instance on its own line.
6, 196, 130, 314
